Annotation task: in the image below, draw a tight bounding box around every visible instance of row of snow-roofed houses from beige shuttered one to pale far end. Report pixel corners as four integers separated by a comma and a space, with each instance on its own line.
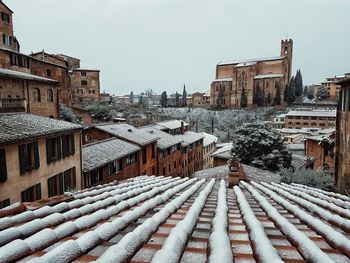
0, 115, 216, 208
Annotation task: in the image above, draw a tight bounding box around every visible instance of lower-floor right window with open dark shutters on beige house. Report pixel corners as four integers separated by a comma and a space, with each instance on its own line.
47, 167, 76, 197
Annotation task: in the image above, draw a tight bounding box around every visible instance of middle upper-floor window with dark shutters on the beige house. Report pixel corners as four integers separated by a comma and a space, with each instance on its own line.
18, 142, 40, 175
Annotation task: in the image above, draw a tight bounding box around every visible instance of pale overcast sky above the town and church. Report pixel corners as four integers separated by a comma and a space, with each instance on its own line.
8, 0, 350, 94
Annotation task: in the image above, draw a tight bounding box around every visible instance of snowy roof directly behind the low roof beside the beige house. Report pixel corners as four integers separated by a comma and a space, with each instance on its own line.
95, 123, 158, 146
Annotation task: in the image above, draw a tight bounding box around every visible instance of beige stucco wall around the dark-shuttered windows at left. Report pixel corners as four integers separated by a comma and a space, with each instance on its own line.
0, 132, 81, 204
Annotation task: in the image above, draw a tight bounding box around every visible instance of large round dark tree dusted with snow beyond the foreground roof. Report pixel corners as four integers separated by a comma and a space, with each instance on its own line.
232, 123, 292, 172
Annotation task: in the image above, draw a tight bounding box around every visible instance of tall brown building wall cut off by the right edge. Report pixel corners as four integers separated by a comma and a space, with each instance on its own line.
335, 78, 350, 191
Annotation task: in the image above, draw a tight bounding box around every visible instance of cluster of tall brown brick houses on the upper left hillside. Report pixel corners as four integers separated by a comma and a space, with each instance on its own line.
0, 1, 100, 118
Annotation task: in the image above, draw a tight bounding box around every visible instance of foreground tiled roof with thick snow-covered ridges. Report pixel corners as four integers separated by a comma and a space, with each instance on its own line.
0, 177, 350, 263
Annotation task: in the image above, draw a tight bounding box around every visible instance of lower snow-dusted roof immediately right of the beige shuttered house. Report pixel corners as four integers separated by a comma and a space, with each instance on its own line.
82, 139, 141, 173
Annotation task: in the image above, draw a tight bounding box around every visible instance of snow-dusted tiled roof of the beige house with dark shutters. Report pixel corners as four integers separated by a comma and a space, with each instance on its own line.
0, 113, 83, 144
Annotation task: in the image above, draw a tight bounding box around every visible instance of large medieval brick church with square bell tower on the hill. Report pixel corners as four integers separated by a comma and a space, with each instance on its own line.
210, 39, 293, 109
